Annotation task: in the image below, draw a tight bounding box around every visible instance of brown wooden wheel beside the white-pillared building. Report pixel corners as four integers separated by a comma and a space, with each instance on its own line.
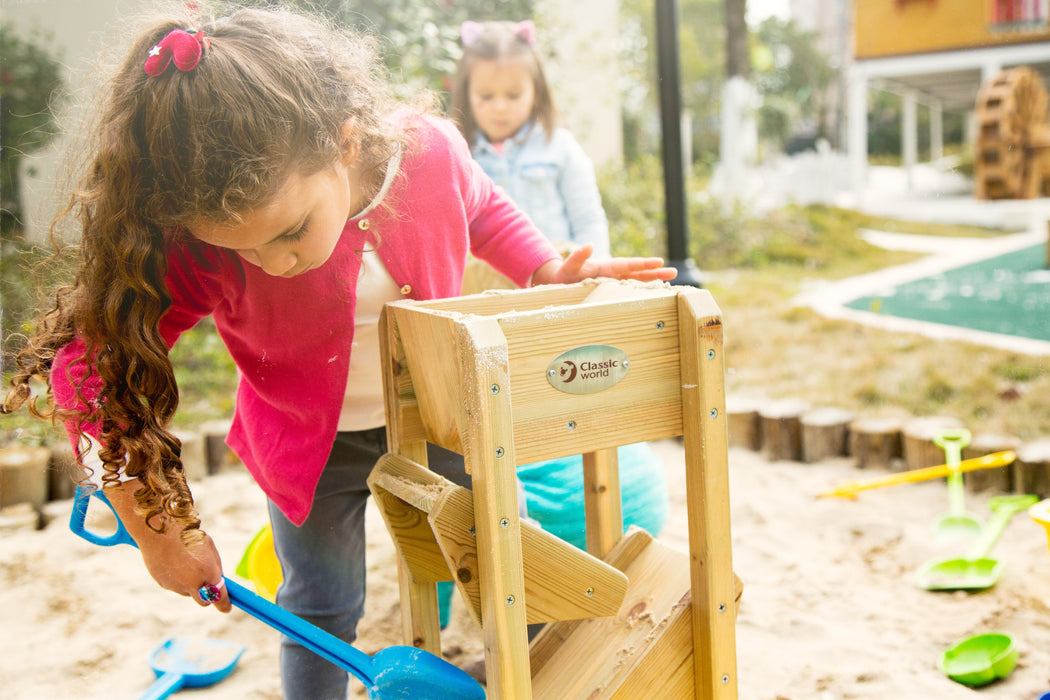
973, 66, 1050, 199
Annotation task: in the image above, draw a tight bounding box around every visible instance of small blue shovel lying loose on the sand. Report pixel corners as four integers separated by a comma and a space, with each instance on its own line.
139, 637, 245, 700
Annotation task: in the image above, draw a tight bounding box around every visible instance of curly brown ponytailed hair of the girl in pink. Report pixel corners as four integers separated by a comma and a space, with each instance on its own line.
0, 3, 401, 544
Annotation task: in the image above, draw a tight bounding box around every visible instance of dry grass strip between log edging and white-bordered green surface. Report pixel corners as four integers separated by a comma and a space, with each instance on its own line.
708, 269, 1050, 440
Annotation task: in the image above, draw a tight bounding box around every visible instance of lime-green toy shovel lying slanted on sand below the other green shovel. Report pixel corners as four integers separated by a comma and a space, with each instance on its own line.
918, 495, 1038, 591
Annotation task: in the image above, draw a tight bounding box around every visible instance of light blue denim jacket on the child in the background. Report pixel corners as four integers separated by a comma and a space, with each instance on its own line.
470, 123, 609, 258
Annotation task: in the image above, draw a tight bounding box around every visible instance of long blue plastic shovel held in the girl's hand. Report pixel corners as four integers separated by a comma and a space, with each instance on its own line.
69, 487, 485, 700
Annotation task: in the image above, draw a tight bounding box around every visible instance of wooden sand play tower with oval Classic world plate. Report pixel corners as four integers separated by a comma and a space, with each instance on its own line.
369, 280, 739, 700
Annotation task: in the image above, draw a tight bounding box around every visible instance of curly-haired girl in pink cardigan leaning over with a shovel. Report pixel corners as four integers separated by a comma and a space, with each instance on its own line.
3, 3, 673, 698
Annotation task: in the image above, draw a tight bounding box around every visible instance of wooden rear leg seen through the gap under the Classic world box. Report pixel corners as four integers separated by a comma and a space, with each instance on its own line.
583, 447, 624, 558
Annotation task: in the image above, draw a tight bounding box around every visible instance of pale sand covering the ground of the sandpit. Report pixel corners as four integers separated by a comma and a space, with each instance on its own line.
0, 441, 1050, 700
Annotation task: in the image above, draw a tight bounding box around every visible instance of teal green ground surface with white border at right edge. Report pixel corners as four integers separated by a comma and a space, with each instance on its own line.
846, 243, 1050, 341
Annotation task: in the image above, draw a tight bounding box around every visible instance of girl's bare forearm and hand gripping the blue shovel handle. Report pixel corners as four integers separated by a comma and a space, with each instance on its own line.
106, 481, 231, 613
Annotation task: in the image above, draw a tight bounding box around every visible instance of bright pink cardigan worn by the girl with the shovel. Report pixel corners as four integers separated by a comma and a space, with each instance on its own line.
51, 118, 559, 525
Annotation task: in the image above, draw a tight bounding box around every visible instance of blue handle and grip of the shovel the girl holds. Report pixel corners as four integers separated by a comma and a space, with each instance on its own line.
69, 486, 375, 687
